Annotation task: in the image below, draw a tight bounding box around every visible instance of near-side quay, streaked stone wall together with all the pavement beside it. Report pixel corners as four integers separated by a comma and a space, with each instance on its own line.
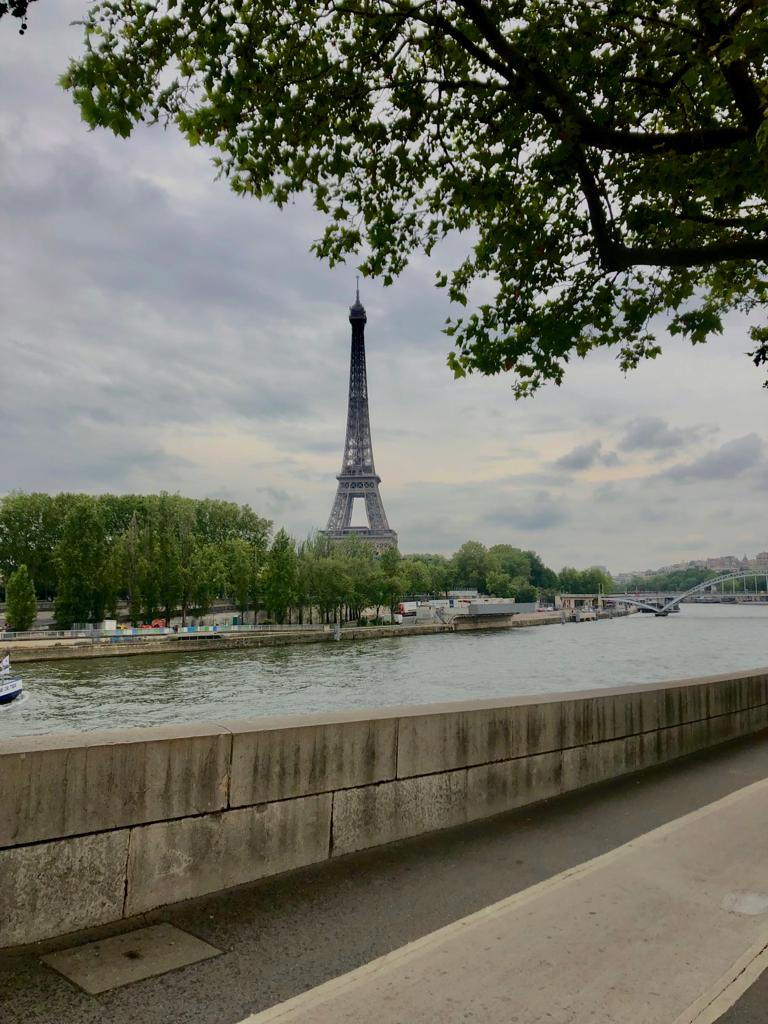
0, 670, 768, 1024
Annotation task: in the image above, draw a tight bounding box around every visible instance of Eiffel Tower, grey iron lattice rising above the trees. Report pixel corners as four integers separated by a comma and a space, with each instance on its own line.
325, 286, 397, 552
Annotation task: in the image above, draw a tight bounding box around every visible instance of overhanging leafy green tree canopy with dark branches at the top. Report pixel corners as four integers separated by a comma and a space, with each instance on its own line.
62, 0, 768, 396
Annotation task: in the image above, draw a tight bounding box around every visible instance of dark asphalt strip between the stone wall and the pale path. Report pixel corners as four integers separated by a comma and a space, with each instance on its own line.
0, 736, 768, 1024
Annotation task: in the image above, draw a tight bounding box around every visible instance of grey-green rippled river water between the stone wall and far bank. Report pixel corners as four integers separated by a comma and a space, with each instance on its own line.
0, 604, 768, 737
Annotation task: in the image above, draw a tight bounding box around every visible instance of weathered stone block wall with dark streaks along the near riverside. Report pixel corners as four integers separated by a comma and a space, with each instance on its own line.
0, 670, 768, 946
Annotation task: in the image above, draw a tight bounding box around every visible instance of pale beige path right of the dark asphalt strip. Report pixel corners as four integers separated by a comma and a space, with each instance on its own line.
243, 780, 768, 1024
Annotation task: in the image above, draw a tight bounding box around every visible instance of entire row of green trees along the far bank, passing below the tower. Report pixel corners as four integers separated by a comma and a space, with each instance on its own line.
0, 493, 610, 629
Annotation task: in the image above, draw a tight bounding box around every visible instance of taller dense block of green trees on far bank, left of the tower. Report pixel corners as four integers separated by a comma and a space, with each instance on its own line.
0, 493, 271, 628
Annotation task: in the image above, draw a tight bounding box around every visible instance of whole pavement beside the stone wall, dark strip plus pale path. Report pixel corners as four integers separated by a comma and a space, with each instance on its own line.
0, 735, 768, 1024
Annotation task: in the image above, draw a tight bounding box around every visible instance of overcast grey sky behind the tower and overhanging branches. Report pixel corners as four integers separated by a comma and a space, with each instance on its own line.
0, 0, 768, 571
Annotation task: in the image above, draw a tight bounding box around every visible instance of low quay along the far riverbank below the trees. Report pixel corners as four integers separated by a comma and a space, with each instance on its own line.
0, 608, 634, 663
